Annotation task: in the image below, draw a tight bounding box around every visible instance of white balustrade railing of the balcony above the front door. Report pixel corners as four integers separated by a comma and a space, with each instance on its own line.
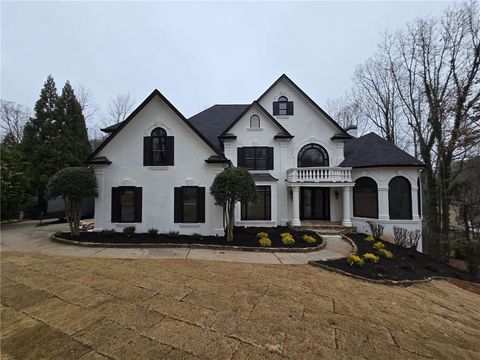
287, 166, 352, 183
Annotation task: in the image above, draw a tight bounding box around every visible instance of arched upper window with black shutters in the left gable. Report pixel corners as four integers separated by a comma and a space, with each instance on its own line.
143, 127, 174, 166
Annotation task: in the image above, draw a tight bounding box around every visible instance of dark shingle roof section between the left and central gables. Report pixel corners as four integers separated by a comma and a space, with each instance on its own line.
188, 104, 250, 151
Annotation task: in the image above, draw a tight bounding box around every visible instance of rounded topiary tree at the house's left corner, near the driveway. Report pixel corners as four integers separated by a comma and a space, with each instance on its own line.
48, 167, 98, 235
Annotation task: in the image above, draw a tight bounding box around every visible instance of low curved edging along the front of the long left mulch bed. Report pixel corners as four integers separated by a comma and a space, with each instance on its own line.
50, 234, 327, 253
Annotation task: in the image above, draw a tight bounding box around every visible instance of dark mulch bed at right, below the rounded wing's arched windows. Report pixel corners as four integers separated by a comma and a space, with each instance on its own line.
320, 234, 478, 281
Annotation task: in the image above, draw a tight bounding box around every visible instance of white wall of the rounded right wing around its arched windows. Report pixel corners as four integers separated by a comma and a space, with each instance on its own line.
351, 167, 422, 251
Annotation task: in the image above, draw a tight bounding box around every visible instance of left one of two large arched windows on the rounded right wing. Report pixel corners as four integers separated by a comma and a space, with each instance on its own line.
353, 176, 378, 219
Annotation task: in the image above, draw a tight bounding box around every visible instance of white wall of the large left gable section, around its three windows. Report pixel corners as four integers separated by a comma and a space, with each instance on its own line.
95, 97, 223, 235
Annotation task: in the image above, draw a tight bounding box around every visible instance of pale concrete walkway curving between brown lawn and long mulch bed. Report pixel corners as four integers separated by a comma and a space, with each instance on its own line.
1, 221, 352, 264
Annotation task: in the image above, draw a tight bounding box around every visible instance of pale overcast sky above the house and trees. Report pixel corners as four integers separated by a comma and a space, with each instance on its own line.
1, 2, 448, 130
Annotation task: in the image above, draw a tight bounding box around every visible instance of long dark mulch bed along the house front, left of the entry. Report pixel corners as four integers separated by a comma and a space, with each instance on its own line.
59, 226, 322, 248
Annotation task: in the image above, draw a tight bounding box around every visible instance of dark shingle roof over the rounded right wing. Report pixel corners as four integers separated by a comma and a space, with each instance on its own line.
340, 132, 424, 168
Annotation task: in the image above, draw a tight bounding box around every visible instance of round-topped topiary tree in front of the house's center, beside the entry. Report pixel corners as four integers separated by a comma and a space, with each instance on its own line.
210, 166, 257, 241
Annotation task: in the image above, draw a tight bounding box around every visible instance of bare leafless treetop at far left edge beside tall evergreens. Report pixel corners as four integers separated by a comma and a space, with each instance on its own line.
0, 100, 30, 144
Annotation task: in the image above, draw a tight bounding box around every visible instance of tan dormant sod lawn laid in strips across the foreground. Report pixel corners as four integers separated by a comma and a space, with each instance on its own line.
1, 252, 480, 359
